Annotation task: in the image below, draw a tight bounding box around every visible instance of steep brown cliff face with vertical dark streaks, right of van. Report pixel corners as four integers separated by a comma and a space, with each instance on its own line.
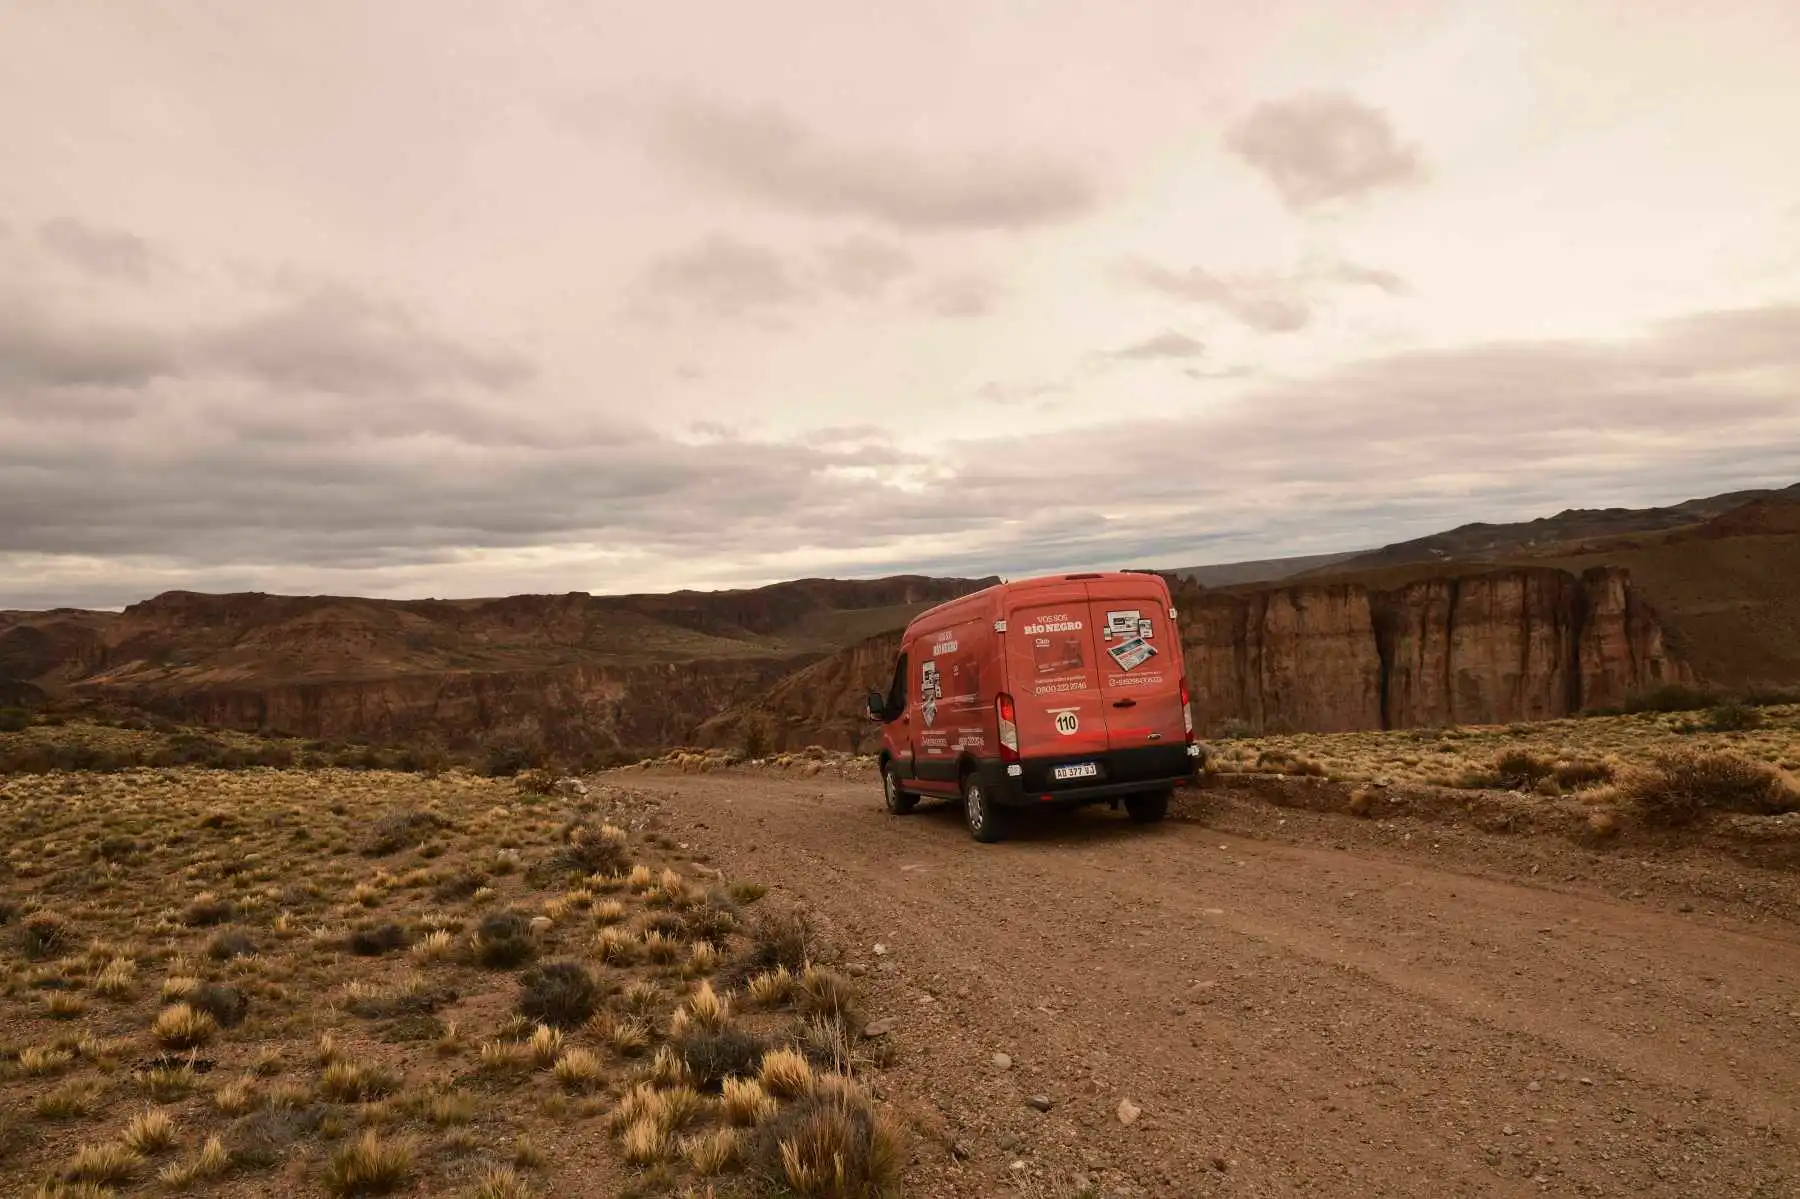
1179, 567, 1683, 733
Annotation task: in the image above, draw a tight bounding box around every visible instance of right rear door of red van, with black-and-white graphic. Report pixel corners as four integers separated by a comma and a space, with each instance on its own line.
1085, 580, 1186, 749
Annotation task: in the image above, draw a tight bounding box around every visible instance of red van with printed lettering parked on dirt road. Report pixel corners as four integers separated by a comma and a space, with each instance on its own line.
869, 571, 1201, 841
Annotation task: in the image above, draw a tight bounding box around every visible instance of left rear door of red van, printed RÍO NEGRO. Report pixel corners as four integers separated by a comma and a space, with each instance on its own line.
1006, 581, 1111, 758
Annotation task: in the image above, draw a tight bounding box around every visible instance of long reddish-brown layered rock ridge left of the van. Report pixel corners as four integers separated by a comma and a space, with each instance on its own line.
0, 576, 992, 753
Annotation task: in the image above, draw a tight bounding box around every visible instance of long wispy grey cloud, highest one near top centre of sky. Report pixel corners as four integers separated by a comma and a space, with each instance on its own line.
653, 103, 1100, 230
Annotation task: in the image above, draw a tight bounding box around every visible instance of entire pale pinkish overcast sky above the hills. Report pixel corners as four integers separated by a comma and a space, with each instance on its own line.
0, 0, 1800, 607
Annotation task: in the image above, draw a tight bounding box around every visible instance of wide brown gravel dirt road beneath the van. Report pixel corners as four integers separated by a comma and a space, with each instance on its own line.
612, 772, 1800, 1197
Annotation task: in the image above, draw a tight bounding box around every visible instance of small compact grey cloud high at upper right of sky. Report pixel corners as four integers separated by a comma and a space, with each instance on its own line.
1226, 92, 1426, 212
